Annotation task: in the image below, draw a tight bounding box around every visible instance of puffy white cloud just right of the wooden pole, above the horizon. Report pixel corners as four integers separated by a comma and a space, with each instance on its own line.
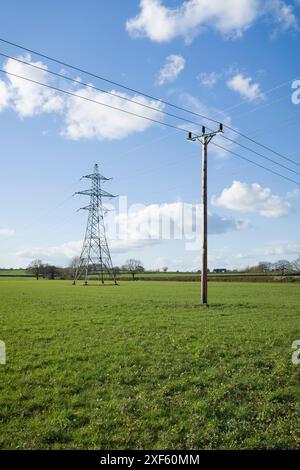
212, 181, 293, 219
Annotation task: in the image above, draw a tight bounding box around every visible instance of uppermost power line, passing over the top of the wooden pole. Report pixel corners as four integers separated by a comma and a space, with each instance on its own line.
0, 38, 300, 171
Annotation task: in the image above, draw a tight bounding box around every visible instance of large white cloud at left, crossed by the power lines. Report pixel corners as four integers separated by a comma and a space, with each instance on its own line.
0, 55, 164, 140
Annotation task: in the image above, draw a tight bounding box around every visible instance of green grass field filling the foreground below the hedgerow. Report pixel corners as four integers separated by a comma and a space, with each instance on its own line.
0, 279, 300, 449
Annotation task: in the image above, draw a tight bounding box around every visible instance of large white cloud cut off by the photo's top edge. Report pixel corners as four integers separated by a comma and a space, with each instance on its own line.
126, 0, 297, 42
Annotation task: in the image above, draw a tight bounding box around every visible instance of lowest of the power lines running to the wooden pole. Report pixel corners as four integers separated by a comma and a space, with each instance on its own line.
0, 69, 300, 186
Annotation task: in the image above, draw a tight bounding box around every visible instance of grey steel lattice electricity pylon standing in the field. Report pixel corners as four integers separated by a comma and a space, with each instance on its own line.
73, 164, 117, 285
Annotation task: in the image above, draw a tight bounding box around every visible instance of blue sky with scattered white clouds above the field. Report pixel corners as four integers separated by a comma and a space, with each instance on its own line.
0, 0, 300, 270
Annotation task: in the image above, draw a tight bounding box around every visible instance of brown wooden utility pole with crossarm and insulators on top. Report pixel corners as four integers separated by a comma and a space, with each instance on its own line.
188, 124, 223, 305
